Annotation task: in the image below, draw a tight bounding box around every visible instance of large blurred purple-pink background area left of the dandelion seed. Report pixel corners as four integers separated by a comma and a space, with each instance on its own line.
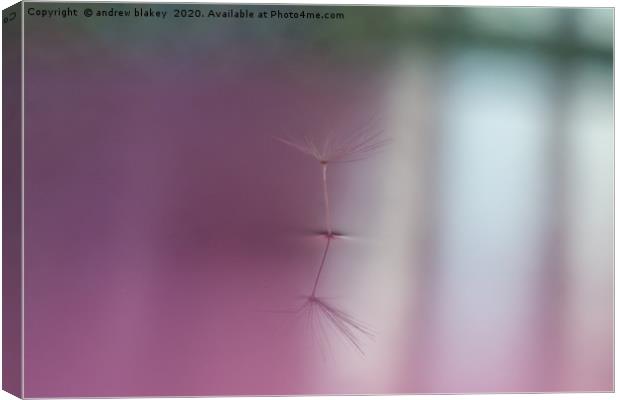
25, 16, 388, 397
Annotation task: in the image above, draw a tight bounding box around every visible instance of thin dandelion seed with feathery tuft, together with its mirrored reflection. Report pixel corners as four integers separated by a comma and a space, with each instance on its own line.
276, 115, 390, 354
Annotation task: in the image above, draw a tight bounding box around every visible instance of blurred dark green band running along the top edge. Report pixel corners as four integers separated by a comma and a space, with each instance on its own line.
26, 3, 613, 64
